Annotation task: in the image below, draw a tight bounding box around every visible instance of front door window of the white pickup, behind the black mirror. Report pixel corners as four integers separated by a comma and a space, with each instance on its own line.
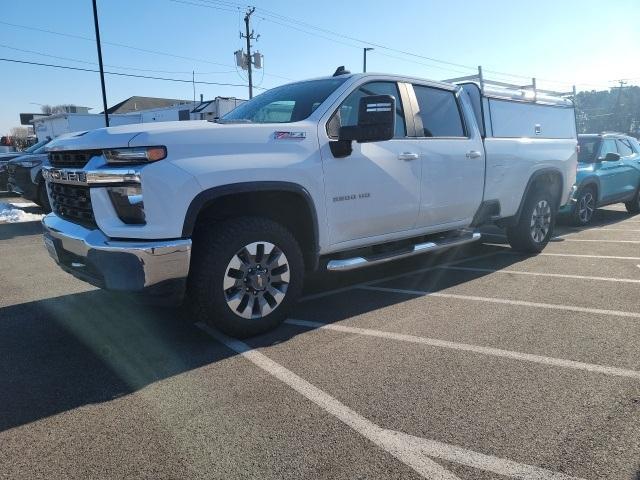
327, 82, 407, 138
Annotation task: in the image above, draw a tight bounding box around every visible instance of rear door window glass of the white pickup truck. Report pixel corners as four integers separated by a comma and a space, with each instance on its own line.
413, 85, 466, 137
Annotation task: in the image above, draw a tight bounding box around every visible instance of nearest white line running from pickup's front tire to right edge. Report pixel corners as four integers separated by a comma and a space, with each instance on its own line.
285, 319, 640, 380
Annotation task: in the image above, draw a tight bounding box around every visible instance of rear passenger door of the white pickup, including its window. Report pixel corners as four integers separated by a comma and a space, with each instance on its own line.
409, 84, 485, 227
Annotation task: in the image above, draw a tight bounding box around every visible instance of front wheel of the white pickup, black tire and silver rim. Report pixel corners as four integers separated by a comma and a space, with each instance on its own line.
188, 217, 304, 338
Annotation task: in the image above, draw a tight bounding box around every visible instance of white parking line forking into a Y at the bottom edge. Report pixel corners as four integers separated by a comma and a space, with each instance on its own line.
198, 324, 579, 480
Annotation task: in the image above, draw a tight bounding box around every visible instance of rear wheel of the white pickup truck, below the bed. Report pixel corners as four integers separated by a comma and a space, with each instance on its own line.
507, 189, 556, 253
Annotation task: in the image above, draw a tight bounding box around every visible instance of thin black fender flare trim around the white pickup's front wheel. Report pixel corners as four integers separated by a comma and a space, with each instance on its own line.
182, 181, 320, 262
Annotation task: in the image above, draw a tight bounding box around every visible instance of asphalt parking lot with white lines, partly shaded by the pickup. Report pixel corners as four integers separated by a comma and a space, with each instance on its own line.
0, 196, 640, 480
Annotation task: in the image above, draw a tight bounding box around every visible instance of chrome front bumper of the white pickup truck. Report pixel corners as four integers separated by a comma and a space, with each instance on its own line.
42, 214, 191, 297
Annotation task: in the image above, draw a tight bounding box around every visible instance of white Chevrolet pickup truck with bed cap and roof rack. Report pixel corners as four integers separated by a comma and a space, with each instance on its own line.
43, 69, 577, 337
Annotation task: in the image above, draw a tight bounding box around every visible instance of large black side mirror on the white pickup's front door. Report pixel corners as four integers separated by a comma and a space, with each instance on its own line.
338, 95, 396, 143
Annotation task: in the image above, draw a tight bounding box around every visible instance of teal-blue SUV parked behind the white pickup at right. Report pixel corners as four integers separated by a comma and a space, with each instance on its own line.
560, 133, 640, 225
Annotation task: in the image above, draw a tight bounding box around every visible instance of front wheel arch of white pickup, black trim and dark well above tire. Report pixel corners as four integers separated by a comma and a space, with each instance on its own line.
182, 181, 319, 270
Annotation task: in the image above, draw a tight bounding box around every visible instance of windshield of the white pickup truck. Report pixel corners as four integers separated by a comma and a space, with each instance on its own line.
219, 77, 345, 123
